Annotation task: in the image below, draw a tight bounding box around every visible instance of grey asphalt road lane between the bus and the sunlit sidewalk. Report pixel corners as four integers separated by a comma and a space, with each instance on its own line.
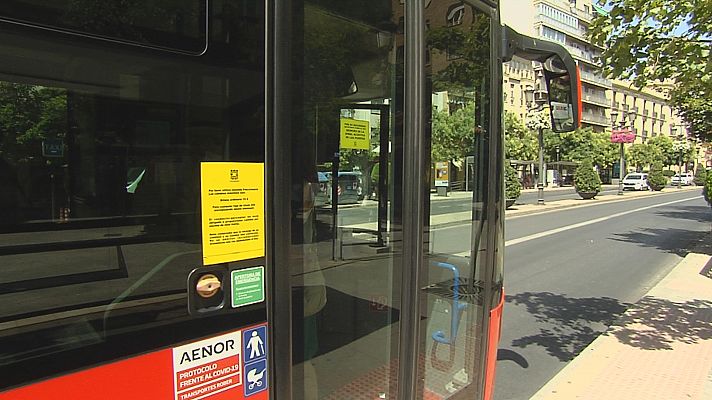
495, 191, 711, 400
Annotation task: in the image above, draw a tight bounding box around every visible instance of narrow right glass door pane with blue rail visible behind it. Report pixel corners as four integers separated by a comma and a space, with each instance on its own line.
419, 1, 494, 398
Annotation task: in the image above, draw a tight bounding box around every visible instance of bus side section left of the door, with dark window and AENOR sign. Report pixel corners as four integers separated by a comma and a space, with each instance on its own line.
0, 0, 272, 399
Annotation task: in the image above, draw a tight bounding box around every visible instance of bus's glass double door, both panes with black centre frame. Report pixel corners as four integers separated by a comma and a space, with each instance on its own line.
275, 0, 503, 400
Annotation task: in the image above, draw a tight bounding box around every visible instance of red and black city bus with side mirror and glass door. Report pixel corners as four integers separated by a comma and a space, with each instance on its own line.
0, 0, 580, 400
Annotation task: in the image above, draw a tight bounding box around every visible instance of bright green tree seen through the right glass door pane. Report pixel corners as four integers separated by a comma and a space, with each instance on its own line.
432, 102, 476, 161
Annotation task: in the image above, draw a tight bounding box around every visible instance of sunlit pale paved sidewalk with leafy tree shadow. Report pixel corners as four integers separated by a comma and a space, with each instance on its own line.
531, 233, 712, 400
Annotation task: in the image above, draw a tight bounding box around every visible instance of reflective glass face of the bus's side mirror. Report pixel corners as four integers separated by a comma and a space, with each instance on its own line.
542, 54, 582, 133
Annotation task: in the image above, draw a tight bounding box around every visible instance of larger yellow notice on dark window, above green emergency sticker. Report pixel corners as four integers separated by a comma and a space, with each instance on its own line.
200, 162, 265, 265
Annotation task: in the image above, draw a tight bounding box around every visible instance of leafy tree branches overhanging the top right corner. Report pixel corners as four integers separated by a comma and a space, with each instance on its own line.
589, 0, 712, 139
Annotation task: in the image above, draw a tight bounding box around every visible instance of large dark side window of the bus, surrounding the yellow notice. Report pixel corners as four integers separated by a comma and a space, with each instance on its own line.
0, 1, 266, 390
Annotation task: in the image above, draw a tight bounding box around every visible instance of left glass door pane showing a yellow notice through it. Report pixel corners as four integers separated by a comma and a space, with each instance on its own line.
290, 1, 403, 399
